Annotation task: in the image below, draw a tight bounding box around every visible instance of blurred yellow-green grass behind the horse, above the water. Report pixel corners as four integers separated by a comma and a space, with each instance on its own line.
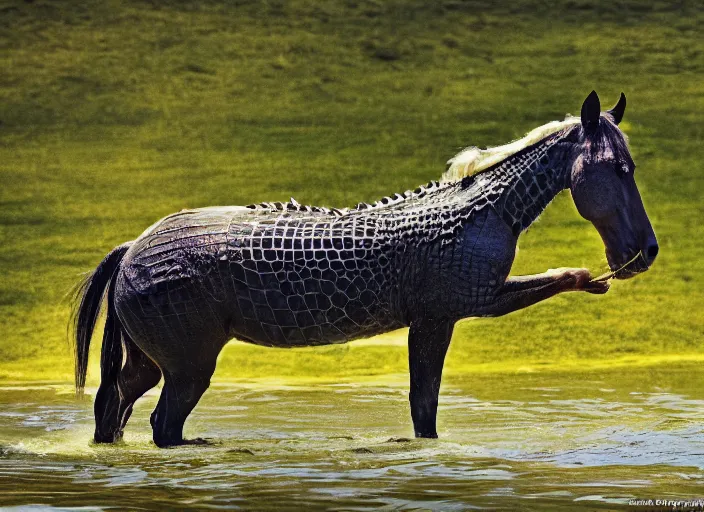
0, 0, 704, 380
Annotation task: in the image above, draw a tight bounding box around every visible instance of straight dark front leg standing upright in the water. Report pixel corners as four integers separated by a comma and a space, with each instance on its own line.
408, 319, 454, 438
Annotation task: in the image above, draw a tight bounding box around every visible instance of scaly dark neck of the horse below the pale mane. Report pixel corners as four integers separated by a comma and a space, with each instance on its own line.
460, 134, 573, 237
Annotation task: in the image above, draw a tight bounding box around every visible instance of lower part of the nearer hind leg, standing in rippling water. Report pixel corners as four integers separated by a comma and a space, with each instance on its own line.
151, 362, 215, 448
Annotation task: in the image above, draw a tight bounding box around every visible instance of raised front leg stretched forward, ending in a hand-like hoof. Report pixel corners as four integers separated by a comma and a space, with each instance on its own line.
474, 268, 609, 316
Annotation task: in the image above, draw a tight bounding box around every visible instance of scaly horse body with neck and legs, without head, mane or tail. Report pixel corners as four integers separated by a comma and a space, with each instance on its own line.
96, 123, 608, 446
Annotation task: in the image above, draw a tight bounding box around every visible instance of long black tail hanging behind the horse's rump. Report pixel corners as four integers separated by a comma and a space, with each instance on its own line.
69, 242, 132, 396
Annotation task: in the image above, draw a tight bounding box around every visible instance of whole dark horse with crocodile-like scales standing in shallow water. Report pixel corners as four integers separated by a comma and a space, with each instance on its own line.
69, 92, 658, 447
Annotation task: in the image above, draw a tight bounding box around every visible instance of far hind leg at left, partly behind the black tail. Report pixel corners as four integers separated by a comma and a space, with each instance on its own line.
93, 333, 161, 443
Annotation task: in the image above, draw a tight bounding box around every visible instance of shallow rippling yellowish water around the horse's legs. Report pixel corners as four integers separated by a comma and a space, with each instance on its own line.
0, 367, 704, 511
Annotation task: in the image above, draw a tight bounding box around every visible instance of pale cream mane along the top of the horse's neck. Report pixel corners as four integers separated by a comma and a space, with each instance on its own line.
440, 116, 580, 182
